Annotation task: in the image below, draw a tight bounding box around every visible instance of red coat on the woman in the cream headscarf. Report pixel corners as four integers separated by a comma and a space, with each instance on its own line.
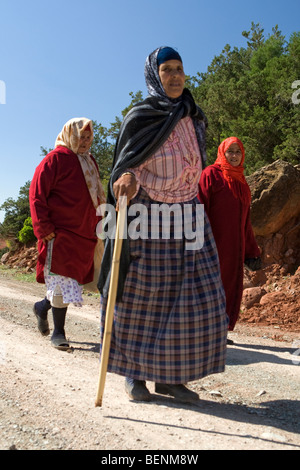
29, 146, 100, 284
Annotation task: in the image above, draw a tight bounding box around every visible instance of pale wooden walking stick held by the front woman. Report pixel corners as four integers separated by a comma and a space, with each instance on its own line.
95, 198, 127, 406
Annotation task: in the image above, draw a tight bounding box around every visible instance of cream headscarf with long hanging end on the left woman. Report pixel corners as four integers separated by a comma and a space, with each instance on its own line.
55, 118, 106, 209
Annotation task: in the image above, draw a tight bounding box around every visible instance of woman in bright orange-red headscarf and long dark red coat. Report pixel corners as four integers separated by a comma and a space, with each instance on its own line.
199, 137, 261, 336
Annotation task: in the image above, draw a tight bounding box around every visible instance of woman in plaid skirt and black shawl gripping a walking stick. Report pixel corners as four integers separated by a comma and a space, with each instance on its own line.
98, 47, 227, 403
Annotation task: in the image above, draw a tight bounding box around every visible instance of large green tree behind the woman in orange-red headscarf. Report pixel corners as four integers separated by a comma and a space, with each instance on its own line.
188, 23, 300, 174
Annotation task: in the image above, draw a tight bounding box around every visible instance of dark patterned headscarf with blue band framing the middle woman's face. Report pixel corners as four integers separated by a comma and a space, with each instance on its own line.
144, 47, 182, 103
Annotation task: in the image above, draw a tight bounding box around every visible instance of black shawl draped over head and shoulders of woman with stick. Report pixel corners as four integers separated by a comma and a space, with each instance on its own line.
98, 48, 207, 301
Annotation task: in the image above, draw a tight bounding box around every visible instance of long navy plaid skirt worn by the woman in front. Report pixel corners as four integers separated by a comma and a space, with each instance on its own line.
100, 191, 228, 384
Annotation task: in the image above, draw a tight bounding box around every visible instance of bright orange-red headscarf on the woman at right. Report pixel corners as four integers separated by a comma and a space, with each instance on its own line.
215, 137, 251, 205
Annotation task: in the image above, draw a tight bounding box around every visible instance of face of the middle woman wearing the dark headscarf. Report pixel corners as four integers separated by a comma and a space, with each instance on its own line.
158, 60, 185, 98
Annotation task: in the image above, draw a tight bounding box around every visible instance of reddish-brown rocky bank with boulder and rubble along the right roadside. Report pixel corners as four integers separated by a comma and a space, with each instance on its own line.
240, 160, 300, 331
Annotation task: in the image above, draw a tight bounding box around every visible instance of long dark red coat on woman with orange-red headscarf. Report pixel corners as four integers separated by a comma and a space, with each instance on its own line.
199, 164, 260, 331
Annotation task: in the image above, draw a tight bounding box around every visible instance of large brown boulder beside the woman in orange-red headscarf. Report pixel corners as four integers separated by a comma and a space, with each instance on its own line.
247, 160, 300, 237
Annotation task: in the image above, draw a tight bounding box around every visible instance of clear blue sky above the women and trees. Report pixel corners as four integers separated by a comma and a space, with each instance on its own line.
0, 0, 300, 222
